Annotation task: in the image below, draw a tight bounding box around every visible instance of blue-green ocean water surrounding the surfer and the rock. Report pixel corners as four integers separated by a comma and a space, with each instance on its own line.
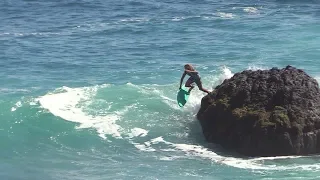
0, 0, 320, 180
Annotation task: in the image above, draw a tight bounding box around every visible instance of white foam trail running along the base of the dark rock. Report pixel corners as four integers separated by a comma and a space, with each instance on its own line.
134, 136, 320, 171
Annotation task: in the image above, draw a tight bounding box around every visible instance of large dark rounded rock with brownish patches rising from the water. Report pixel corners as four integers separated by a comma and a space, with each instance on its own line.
197, 66, 320, 156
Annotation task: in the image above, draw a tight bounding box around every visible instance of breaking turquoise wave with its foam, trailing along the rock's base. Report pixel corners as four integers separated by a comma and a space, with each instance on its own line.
20, 66, 320, 171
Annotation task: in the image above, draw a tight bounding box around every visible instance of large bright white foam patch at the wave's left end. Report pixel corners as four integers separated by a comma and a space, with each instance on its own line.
37, 85, 125, 138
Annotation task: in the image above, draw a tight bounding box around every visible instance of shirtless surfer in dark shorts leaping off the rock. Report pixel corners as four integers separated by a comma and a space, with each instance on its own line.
179, 64, 210, 94
